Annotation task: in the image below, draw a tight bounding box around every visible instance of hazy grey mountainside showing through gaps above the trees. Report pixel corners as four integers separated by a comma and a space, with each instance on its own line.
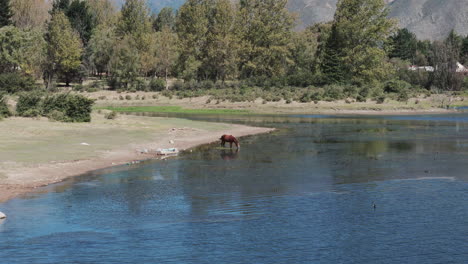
135, 0, 468, 40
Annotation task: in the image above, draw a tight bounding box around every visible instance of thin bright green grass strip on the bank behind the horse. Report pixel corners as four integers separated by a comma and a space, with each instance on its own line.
98, 106, 250, 114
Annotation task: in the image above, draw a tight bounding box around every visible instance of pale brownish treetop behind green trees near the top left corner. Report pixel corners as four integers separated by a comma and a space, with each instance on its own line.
11, 0, 50, 29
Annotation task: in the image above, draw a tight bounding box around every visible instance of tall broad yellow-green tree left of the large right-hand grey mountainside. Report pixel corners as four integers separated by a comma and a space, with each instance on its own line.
322, 0, 396, 84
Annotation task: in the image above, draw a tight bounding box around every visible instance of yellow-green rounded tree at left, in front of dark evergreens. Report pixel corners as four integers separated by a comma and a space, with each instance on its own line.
45, 11, 83, 88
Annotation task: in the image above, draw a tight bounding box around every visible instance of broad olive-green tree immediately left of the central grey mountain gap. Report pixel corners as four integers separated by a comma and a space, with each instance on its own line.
236, 0, 294, 77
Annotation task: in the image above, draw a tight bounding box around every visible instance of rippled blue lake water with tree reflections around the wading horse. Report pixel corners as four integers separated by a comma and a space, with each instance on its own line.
0, 114, 468, 264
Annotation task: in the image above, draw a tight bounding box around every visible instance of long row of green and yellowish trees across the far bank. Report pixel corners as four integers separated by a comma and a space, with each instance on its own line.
0, 0, 468, 92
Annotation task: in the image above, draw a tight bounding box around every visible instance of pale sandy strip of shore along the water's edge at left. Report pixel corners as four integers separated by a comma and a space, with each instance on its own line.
0, 117, 273, 202
